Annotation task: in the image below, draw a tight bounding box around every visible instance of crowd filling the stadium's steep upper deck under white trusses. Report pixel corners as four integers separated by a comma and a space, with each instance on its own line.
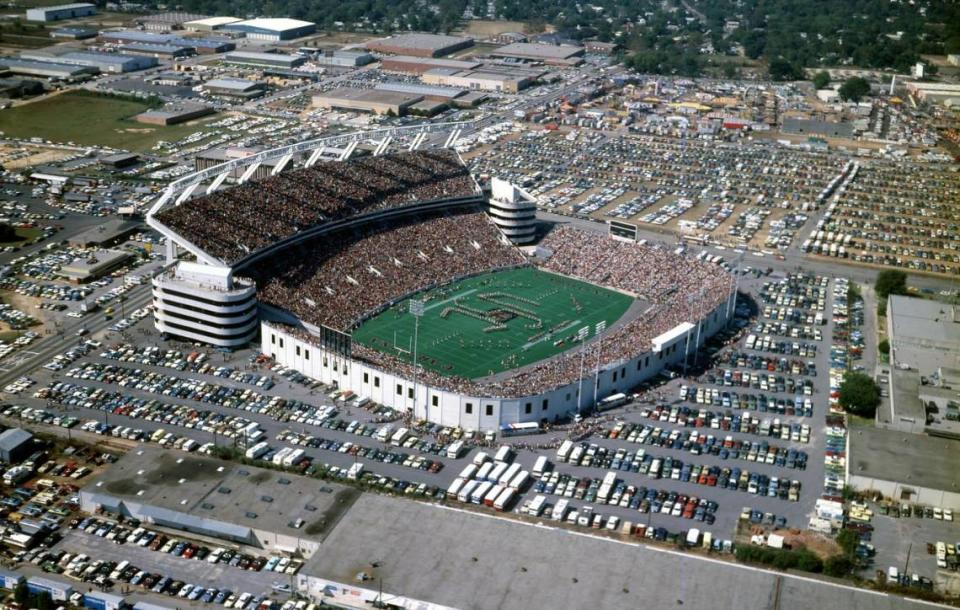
156, 149, 476, 264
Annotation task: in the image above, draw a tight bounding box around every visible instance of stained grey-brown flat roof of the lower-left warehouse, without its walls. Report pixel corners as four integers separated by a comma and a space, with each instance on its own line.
83, 445, 358, 538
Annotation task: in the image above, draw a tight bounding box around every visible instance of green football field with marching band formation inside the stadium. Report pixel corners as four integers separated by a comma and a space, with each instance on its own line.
353, 267, 633, 379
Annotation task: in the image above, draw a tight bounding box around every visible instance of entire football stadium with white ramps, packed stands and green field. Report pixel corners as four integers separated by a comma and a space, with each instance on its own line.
148, 124, 736, 430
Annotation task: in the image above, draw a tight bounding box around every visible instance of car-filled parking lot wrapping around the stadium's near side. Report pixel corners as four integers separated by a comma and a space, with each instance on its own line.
0, 264, 833, 539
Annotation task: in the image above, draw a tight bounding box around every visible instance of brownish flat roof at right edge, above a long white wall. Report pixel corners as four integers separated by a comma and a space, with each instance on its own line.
847, 428, 960, 493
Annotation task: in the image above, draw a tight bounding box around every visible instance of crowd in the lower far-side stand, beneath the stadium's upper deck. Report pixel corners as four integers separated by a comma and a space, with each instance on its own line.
251, 208, 525, 331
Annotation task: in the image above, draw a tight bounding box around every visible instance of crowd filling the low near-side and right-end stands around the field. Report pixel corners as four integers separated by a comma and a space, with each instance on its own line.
274, 226, 734, 398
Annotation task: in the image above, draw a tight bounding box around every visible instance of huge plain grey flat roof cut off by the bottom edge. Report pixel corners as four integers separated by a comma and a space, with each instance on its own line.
299, 494, 925, 610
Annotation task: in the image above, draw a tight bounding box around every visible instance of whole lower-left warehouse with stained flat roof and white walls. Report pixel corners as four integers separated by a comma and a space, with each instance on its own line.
80, 445, 348, 557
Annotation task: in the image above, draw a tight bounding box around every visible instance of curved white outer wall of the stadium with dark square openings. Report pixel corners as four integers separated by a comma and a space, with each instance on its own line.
260, 301, 732, 430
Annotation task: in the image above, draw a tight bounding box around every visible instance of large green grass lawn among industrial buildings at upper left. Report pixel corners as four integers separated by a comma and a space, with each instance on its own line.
0, 91, 216, 152
